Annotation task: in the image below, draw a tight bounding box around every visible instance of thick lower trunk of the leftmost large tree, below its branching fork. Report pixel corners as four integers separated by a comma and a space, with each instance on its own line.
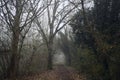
7, 28, 19, 80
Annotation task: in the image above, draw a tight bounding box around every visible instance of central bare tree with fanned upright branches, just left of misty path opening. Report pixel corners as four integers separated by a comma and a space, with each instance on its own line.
36, 0, 75, 69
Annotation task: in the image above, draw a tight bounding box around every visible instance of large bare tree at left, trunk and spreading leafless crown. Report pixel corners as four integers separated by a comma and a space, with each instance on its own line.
0, 0, 44, 80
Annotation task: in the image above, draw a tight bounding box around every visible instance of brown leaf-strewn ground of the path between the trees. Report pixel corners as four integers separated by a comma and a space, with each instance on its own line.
17, 65, 86, 80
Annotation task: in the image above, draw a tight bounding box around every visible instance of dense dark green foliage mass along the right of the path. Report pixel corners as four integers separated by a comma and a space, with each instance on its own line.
70, 0, 120, 80
